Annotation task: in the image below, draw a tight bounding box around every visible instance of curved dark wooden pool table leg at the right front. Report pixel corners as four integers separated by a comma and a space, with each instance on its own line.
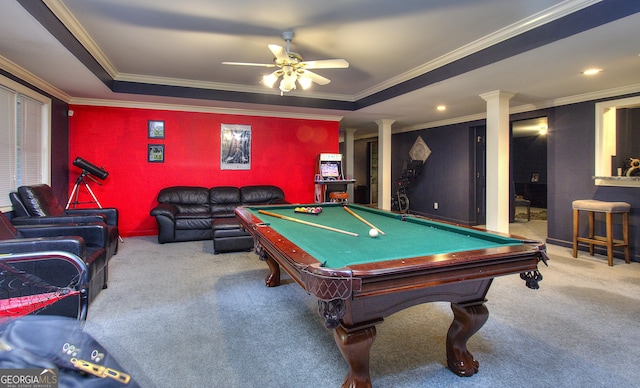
447, 303, 489, 376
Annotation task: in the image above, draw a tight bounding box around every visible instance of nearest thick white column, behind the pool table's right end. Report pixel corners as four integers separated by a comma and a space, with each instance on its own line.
480, 90, 515, 233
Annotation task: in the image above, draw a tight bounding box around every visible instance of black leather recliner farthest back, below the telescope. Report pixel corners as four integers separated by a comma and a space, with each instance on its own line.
9, 184, 119, 259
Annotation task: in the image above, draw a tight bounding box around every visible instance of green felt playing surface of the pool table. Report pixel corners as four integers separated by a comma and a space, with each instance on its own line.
242, 204, 522, 268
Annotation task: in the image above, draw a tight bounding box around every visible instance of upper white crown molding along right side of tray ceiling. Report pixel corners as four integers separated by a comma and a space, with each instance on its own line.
354, 0, 602, 101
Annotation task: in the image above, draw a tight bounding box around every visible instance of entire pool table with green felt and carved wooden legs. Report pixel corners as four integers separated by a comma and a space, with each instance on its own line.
235, 204, 546, 387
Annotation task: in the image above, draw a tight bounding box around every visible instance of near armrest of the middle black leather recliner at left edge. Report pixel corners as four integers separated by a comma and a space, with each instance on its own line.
0, 236, 86, 258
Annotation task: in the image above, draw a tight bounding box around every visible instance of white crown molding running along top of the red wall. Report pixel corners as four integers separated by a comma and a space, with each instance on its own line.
69, 98, 343, 122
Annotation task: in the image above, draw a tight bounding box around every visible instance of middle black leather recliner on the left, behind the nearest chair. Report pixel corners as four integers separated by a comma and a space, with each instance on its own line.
0, 212, 108, 303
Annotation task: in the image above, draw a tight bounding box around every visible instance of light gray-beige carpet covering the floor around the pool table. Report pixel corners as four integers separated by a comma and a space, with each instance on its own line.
85, 220, 640, 388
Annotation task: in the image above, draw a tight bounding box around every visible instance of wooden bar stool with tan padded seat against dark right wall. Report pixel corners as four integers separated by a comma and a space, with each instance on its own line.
572, 199, 631, 266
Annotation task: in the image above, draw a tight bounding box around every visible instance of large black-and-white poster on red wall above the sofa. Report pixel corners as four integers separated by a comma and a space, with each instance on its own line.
220, 124, 251, 170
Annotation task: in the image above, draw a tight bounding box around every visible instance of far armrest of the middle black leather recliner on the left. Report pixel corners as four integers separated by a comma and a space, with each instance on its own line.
16, 222, 109, 247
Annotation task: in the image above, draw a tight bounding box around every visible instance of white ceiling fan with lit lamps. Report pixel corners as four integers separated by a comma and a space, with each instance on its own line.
222, 31, 349, 95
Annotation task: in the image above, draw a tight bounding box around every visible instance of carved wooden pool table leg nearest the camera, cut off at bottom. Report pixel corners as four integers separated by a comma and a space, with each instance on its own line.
333, 326, 376, 388
